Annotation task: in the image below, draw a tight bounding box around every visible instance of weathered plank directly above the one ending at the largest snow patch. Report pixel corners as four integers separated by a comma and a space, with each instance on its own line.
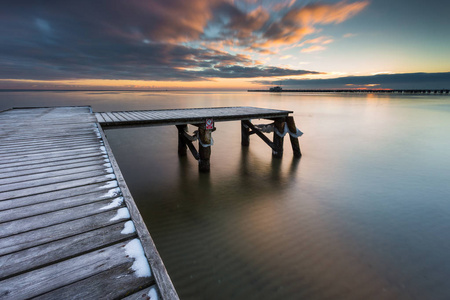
0, 221, 136, 280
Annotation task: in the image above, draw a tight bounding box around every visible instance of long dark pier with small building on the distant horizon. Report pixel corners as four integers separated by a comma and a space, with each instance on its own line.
247, 89, 450, 95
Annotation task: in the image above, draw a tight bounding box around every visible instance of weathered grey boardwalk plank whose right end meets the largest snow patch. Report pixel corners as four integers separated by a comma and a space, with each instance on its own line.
0, 242, 151, 300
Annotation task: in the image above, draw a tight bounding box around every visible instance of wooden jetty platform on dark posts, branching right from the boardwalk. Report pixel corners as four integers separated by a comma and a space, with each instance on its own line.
95, 107, 302, 172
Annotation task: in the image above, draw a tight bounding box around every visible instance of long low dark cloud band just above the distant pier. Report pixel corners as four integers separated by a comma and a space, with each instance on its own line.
258, 72, 450, 89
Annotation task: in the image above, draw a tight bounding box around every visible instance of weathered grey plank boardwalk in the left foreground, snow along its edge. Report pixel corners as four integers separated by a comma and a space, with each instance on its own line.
0, 107, 178, 299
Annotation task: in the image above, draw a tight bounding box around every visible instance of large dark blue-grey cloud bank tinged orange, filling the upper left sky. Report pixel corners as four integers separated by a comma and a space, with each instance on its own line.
0, 0, 324, 81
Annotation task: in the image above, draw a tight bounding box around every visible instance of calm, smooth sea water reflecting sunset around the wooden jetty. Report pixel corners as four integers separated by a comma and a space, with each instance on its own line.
0, 92, 450, 299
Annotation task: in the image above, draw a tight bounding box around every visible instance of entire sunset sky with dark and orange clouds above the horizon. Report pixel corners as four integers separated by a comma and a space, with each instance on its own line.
0, 0, 450, 90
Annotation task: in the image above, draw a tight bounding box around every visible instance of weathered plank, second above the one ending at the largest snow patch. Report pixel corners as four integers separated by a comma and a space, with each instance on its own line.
0, 210, 128, 256
